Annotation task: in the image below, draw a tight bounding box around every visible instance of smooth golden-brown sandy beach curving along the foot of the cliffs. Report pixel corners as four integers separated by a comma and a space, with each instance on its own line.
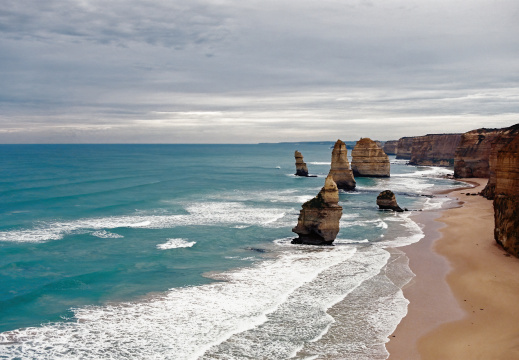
387, 179, 519, 360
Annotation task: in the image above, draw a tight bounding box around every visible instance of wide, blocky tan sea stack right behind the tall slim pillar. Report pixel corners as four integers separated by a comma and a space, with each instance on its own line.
351, 138, 389, 177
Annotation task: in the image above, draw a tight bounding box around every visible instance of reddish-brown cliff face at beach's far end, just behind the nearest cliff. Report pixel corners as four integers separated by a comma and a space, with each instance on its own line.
454, 129, 508, 178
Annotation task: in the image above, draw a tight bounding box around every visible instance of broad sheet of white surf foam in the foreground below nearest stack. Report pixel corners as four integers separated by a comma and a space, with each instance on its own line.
0, 243, 360, 359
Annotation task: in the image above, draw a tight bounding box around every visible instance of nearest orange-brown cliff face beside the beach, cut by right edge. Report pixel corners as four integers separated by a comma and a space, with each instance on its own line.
494, 135, 519, 257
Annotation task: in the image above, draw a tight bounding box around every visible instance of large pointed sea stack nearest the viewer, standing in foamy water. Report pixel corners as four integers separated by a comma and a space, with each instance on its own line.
292, 175, 342, 245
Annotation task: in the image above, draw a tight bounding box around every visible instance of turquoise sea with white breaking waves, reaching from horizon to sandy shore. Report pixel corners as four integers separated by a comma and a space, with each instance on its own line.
0, 142, 460, 360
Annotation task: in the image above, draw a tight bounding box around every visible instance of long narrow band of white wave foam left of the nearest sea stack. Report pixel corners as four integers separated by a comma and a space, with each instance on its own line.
0, 202, 287, 242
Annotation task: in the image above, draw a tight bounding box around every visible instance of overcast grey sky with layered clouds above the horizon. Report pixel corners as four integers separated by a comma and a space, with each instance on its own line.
0, 0, 519, 143
